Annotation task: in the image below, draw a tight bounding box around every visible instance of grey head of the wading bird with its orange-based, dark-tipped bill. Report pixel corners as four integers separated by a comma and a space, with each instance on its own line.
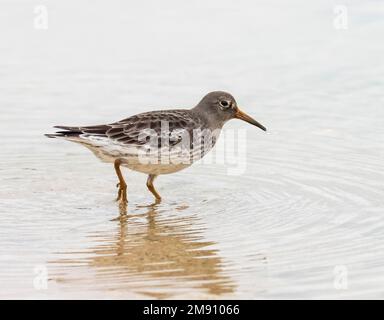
194, 91, 267, 131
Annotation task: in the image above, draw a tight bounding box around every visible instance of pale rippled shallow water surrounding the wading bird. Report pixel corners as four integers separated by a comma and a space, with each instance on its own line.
0, 0, 384, 299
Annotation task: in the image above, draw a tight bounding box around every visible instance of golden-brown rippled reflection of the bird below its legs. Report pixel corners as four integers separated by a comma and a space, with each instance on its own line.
55, 204, 234, 298
